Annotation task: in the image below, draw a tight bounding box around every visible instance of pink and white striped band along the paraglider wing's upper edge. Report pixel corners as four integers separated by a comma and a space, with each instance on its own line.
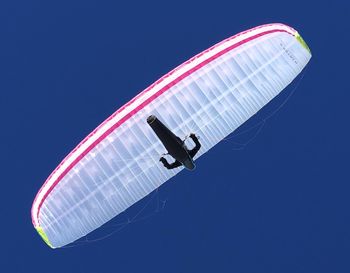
31, 24, 295, 226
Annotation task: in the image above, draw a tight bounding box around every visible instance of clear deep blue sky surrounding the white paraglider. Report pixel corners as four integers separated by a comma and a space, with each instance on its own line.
0, 0, 350, 273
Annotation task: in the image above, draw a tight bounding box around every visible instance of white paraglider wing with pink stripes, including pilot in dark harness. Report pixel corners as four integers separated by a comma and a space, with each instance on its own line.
31, 24, 311, 248
